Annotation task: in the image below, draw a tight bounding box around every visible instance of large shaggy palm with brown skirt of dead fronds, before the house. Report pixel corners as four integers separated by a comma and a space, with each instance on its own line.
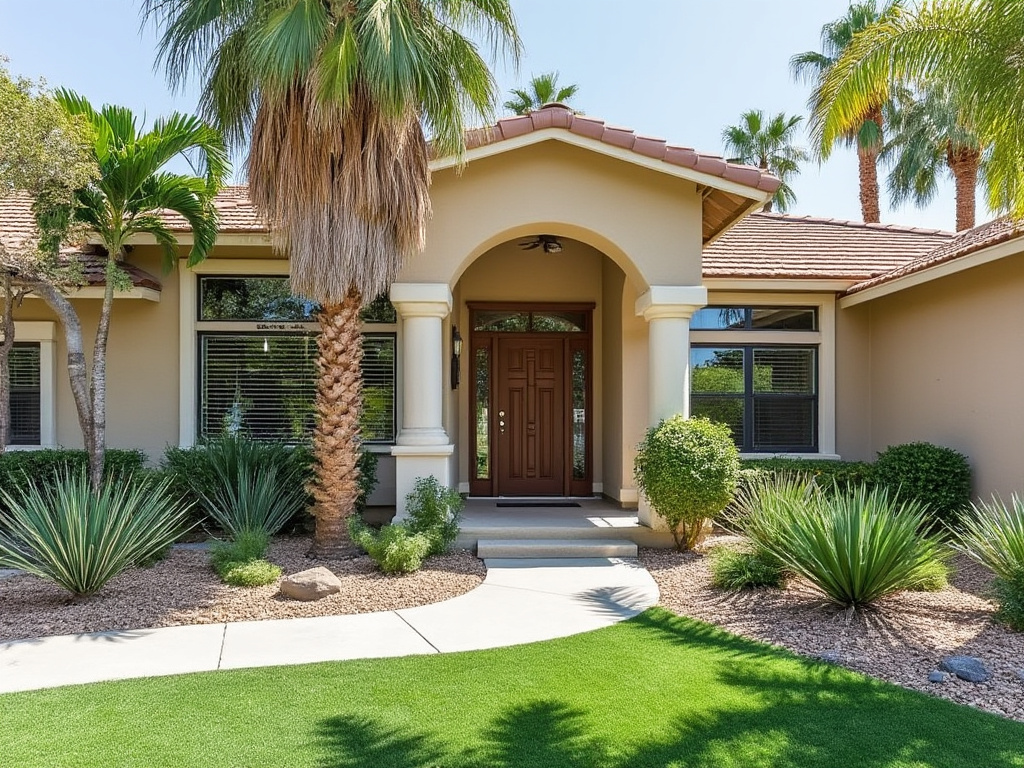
143, 0, 520, 557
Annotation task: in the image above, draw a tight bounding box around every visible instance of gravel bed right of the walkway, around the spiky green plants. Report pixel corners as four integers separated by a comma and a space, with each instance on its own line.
640, 536, 1024, 722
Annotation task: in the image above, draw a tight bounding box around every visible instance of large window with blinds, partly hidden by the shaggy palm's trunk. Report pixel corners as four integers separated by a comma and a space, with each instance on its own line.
197, 275, 396, 443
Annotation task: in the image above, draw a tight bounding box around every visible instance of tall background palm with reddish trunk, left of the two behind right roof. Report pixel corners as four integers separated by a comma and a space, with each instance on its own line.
790, 0, 899, 222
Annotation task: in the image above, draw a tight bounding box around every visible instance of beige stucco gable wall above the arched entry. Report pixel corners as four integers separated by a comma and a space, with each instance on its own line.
398, 140, 701, 288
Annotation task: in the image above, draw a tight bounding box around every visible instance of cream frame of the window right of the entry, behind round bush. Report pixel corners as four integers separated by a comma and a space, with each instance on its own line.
687, 291, 840, 459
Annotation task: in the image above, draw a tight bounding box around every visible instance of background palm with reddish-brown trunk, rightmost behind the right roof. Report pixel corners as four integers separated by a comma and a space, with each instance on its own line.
882, 85, 982, 231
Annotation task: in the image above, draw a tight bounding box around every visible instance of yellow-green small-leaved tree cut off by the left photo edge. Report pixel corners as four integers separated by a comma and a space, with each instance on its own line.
0, 63, 97, 453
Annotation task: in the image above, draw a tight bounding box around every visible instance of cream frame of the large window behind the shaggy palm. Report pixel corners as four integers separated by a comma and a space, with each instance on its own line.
178, 258, 402, 454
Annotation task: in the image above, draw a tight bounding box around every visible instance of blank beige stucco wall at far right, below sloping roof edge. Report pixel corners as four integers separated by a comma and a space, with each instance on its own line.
855, 254, 1024, 496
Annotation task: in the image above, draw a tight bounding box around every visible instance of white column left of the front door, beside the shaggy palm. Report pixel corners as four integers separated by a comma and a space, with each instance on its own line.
390, 283, 455, 520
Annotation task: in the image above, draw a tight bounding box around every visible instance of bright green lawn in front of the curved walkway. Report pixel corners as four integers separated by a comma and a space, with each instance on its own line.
0, 608, 1024, 768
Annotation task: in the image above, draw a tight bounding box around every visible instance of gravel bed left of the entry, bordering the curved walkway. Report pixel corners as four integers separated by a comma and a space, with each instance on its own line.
0, 537, 485, 642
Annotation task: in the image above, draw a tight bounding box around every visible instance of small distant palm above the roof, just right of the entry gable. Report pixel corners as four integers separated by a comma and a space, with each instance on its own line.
722, 110, 807, 213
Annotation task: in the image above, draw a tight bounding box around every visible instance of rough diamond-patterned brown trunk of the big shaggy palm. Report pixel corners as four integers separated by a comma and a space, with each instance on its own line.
309, 287, 362, 558
